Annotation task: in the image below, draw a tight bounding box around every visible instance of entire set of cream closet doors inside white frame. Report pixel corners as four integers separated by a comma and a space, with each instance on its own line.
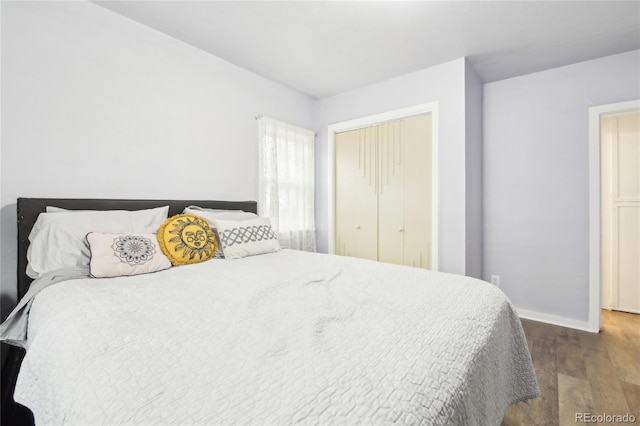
335, 114, 433, 269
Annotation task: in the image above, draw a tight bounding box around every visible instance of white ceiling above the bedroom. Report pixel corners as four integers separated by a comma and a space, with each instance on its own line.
95, 1, 640, 98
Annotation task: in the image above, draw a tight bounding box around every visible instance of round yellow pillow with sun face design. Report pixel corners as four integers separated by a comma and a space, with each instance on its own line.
158, 214, 218, 265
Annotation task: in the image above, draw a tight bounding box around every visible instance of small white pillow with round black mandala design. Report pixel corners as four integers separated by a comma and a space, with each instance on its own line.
87, 232, 171, 278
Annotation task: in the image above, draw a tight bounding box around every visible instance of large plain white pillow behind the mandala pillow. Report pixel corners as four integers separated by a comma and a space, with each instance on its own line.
27, 206, 169, 278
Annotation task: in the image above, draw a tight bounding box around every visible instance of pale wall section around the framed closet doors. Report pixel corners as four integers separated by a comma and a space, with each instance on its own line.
316, 58, 466, 274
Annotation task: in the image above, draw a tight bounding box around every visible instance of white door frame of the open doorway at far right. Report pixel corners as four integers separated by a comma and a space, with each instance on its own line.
588, 99, 640, 333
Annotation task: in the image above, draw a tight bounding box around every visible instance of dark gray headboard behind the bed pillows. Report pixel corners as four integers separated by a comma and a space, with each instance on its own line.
18, 198, 258, 300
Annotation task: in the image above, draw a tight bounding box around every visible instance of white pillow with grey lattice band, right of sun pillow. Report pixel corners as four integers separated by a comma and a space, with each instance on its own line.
216, 217, 280, 259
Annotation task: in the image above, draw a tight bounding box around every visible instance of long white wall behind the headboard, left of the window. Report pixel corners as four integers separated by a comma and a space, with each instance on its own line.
0, 2, 314, 318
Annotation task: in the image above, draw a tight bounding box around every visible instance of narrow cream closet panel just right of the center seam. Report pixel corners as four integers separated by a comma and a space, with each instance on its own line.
378, 122, 404, 265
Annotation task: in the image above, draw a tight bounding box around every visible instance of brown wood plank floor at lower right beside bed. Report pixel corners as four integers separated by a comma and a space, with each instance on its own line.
502, 310, 640, 426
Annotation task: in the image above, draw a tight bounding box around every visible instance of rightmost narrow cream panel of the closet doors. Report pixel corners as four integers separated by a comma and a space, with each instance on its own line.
402, 115, 433, 269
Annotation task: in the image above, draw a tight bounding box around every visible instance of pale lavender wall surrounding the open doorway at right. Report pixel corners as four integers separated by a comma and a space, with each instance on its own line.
483, 51, 640, 327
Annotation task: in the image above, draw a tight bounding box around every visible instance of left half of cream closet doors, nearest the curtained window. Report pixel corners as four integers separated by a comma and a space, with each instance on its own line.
335, 128, 378, 260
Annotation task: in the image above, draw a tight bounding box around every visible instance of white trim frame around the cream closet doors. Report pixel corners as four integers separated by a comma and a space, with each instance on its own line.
327, 102, 438, 271
